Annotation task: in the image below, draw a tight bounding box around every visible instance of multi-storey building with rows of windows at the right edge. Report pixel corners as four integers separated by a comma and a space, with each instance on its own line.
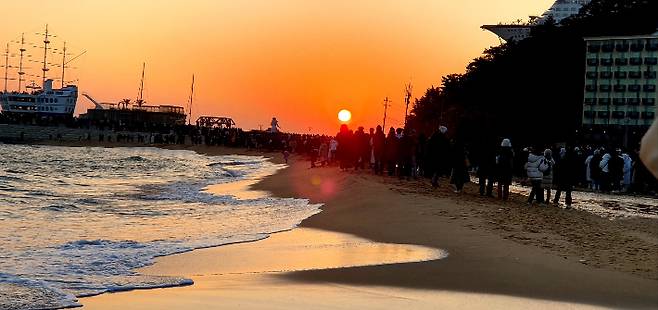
582, 32, 658, 130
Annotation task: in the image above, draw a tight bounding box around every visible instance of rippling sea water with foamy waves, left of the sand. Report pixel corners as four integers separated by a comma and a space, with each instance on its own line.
0, 144, 320, 309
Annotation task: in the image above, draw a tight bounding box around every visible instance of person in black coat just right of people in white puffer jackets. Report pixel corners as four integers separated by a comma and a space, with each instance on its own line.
553, 148, 580, 208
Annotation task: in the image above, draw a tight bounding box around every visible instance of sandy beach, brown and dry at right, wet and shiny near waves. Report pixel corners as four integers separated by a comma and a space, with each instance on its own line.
59, 147, 658, 309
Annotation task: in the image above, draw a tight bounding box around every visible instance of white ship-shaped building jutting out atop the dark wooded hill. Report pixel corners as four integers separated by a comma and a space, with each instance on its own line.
480, 0, 591, 41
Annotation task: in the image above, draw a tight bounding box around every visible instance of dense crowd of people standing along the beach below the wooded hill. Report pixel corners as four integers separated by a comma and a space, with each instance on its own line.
298, 125, 658, 206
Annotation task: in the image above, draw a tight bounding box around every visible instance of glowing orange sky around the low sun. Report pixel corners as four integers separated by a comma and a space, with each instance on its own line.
0, 0, 554, 133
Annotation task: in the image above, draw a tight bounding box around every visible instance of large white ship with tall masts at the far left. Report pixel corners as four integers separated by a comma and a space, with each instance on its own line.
0, 25, 84, 118
